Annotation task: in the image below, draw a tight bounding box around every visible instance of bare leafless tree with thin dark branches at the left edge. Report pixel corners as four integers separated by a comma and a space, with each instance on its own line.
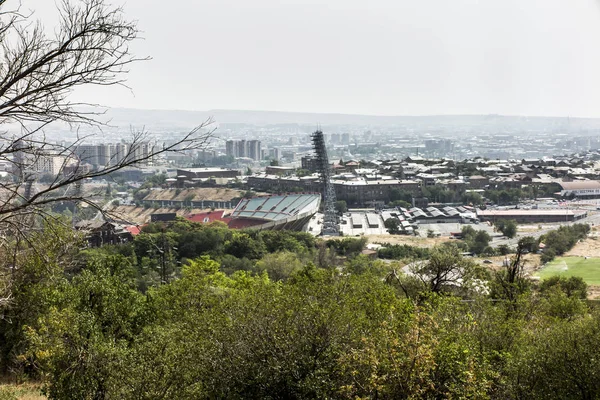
0, 0, 212, 304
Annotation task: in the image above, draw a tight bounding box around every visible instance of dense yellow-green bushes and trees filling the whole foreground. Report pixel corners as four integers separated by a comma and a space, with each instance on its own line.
0, 226, 600, 399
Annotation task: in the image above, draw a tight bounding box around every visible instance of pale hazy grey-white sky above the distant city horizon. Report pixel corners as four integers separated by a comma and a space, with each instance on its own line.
24, 0, 600, 117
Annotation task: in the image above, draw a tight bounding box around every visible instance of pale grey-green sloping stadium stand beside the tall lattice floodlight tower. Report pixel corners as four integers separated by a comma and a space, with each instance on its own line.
228, 193, 321, 231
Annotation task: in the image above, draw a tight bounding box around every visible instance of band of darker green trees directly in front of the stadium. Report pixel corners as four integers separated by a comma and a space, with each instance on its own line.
78, 220, 365, 292
